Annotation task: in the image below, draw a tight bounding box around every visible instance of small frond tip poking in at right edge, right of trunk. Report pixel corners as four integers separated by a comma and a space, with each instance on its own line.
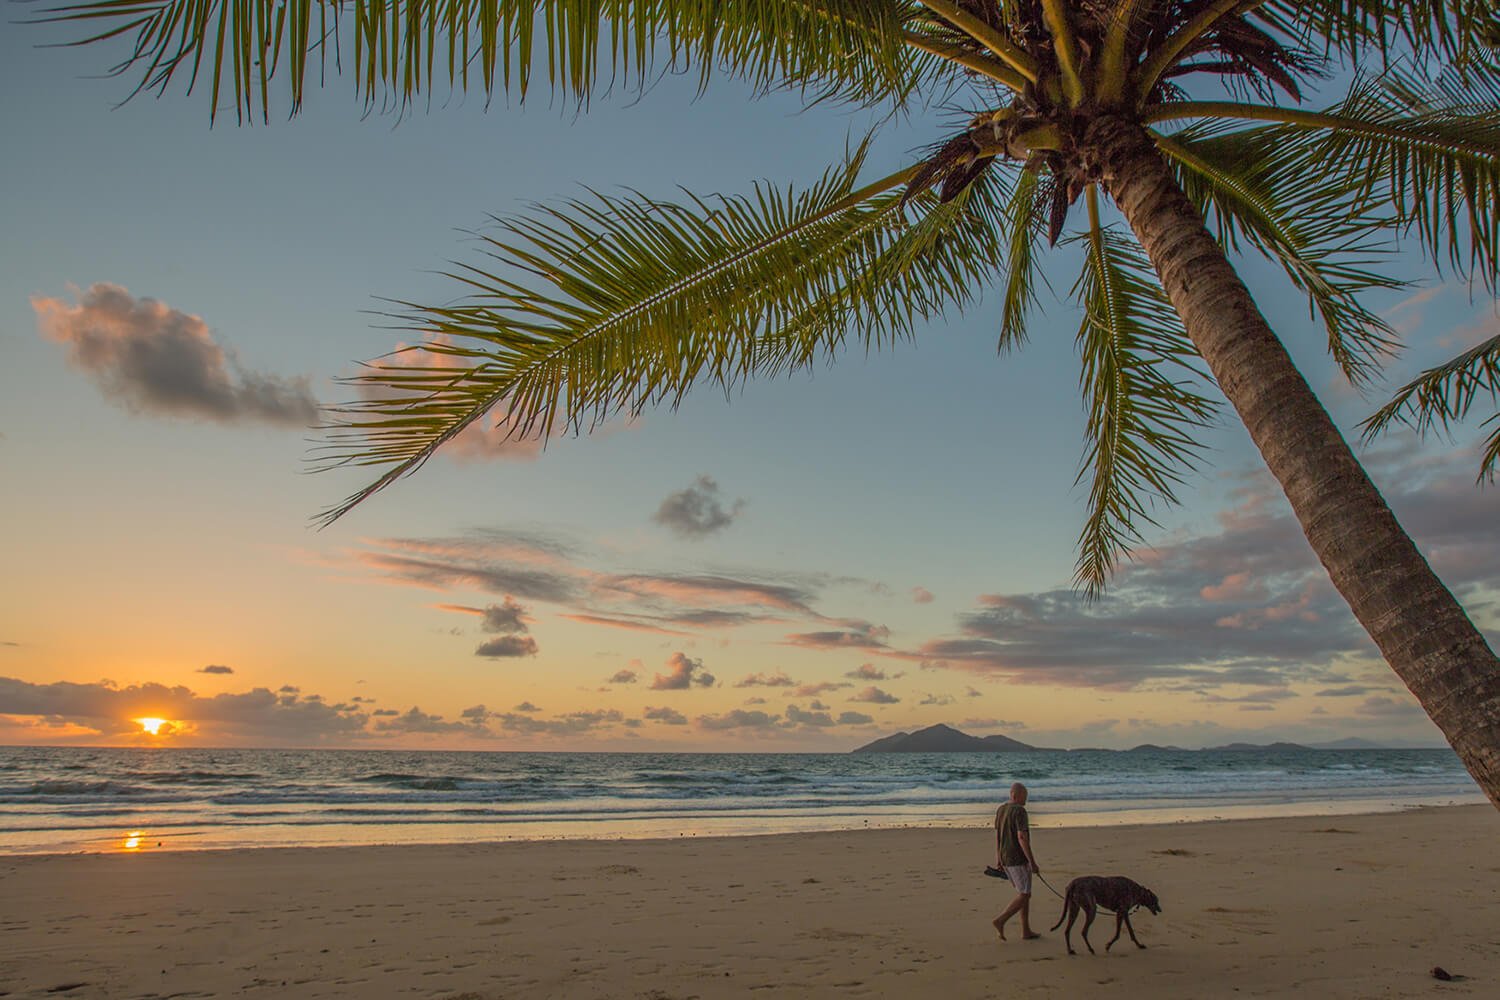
1361, 336, 1500, 483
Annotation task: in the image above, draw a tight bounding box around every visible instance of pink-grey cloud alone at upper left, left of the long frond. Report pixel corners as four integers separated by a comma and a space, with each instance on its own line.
32, 282, 318, 427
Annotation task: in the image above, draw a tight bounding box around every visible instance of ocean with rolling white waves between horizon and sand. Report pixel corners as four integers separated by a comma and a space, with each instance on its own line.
0, 747, 1485, 855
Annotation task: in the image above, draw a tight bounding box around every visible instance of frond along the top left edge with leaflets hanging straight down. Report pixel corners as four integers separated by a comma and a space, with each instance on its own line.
33, 0, 920, 121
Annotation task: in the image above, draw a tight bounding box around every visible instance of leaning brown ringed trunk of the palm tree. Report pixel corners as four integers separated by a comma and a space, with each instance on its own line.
1085, 117, 1500, 808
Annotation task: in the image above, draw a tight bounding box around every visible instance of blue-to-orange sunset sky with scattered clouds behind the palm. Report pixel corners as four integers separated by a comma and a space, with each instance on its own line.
0, 3, 1500, 751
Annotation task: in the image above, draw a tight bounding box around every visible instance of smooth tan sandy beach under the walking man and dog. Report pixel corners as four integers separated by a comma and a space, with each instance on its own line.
0, 805, 1500, 1000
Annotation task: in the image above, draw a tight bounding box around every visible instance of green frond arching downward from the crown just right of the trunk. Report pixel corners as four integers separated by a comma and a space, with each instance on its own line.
1155, 129, 1404, 385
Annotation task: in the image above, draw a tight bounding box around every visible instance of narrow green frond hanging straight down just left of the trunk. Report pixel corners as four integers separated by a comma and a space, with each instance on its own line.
1073, 186, 1217, 597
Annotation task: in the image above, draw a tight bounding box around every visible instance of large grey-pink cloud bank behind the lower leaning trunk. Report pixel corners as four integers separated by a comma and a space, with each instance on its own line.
887, 448, 1500, 691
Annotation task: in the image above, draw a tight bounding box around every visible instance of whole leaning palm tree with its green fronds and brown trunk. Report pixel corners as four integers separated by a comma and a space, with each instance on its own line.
32, 0, 1500, 807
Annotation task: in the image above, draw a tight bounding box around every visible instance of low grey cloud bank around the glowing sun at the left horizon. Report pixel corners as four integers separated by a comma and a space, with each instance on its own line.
0, 678, 368, 745
